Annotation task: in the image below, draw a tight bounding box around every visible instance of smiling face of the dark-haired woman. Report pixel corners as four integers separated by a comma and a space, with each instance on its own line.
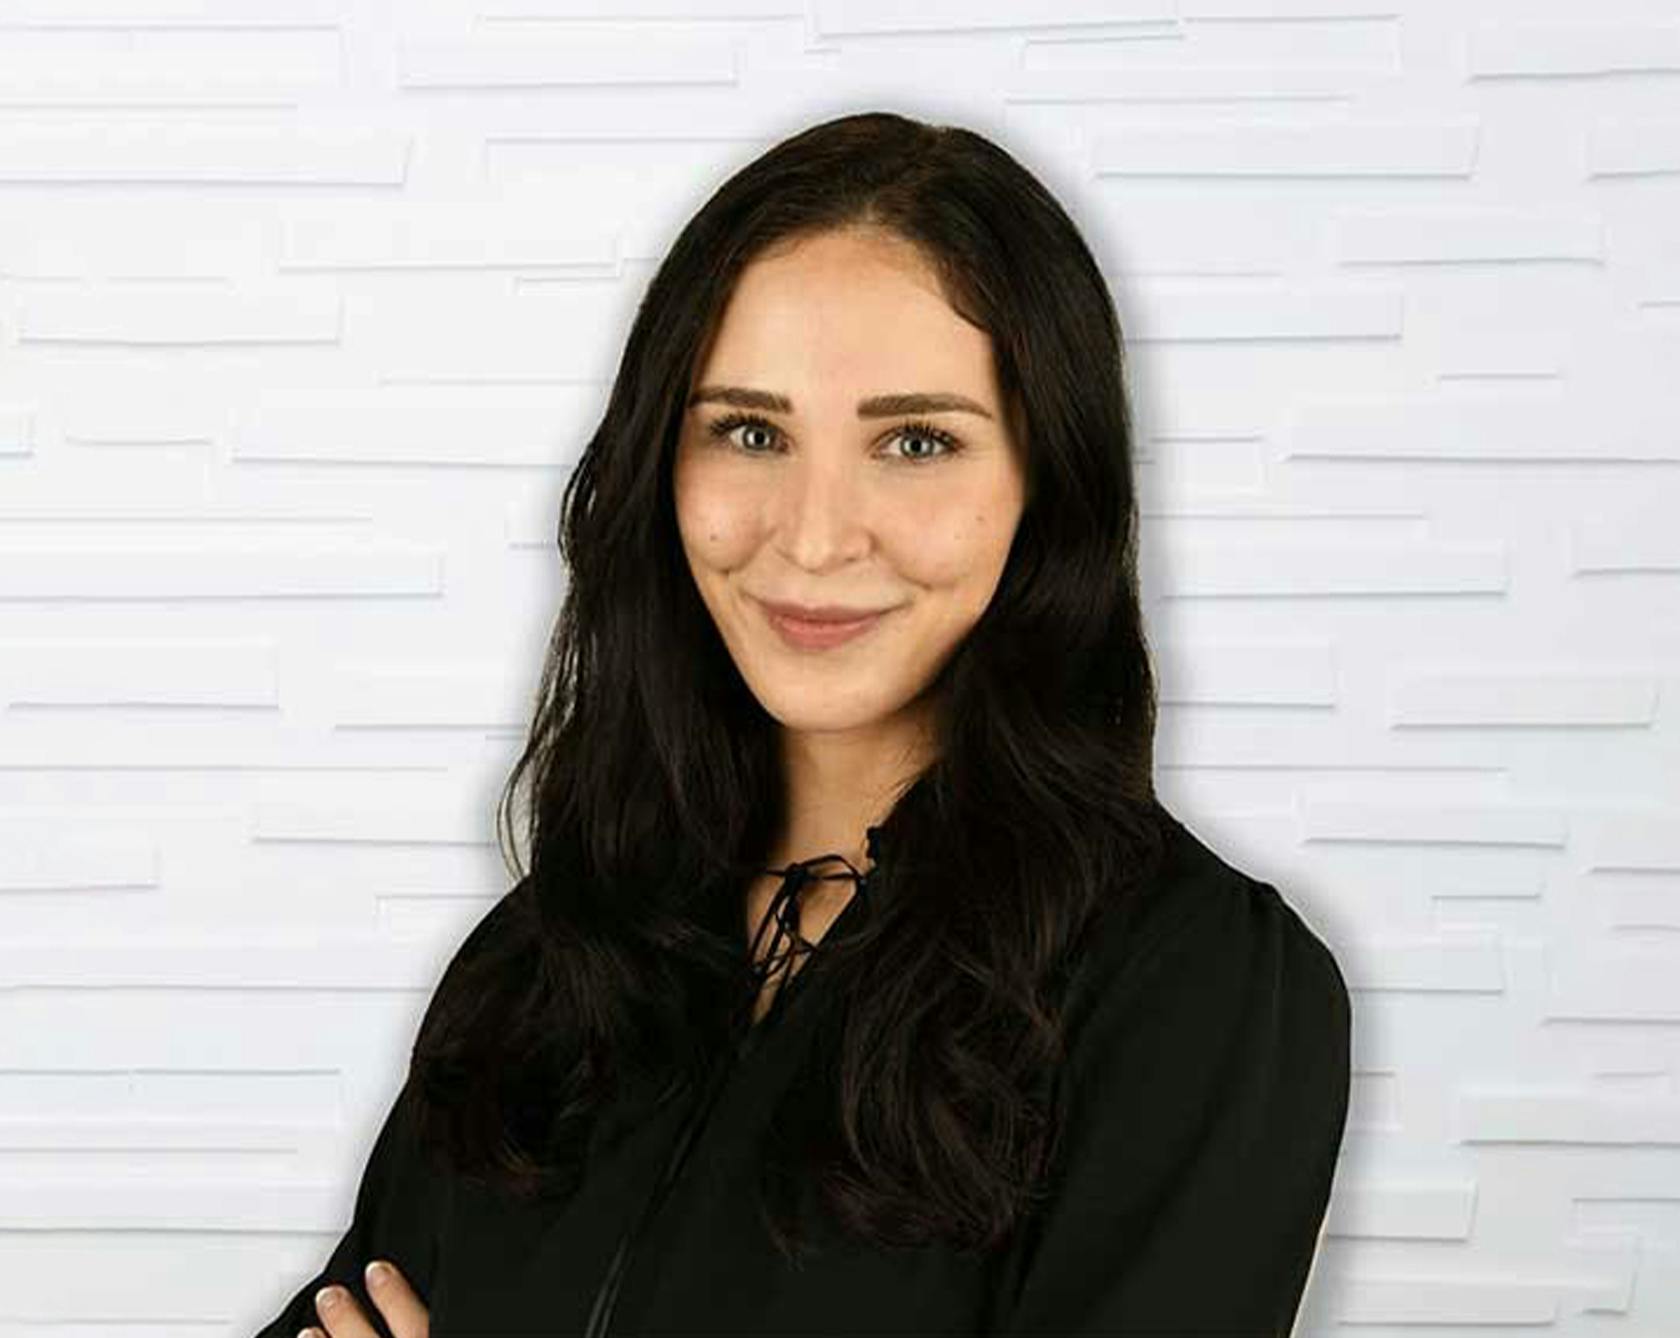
674, 229, 1025, 731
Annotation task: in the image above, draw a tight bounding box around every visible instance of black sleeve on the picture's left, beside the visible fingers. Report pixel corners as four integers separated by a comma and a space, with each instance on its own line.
255, 1081, 440, 1338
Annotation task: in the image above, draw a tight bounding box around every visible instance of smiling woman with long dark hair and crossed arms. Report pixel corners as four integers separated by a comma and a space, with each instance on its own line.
251, 114, 1349, 1338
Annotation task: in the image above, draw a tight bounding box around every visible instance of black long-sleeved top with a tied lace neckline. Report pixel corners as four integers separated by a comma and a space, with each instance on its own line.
257, 820, 1351, 1338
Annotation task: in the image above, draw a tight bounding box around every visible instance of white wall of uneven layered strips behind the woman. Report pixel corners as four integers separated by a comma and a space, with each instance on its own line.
0, 0, 1680, 1338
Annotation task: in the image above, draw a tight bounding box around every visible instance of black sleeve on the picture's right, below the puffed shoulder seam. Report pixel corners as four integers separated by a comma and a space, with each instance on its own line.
993, 881, 1351, 1338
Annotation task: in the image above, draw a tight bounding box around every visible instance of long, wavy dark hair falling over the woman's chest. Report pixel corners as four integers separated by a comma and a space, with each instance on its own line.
412, 113, 1164, 1257
